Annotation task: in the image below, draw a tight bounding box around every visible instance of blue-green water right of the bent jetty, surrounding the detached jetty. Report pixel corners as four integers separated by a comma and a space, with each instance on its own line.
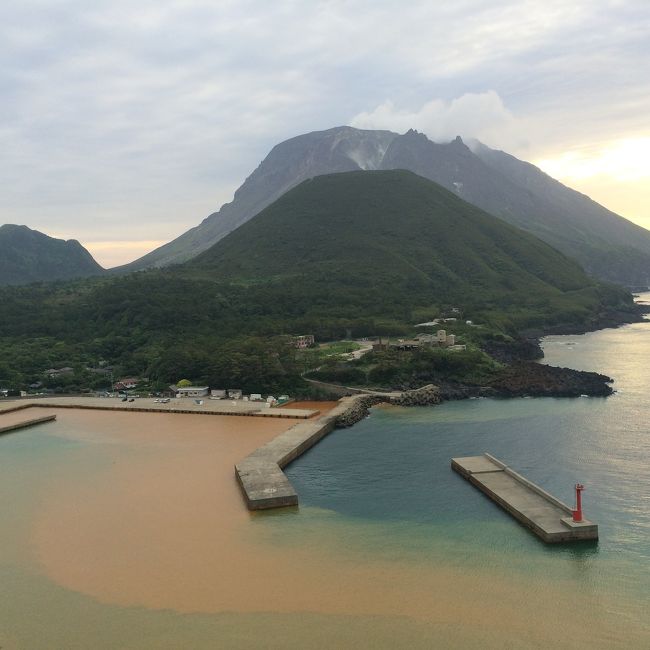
287, 306, 650, 636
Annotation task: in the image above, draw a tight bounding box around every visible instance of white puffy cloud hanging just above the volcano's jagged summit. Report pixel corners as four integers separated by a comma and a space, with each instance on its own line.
350, 90, 518, 147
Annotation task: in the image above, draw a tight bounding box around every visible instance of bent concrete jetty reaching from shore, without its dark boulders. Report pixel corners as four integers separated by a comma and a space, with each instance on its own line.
235, 396, 360, 510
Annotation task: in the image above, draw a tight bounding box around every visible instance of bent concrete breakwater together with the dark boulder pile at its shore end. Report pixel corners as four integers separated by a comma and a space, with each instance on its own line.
235, 386, 441, 510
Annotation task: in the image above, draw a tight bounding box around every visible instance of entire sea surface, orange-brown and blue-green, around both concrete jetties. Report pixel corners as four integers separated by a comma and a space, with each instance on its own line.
0, 295, 650, 650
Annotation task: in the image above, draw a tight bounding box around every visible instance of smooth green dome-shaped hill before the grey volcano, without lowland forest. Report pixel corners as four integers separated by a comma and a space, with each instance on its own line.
187, 171, 620, 327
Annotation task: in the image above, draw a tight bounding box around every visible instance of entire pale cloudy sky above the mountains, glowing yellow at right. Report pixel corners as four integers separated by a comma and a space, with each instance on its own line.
0, 0, 650, 267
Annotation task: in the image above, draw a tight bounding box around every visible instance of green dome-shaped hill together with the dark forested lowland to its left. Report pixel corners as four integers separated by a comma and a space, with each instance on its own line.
0, 171, 632, 392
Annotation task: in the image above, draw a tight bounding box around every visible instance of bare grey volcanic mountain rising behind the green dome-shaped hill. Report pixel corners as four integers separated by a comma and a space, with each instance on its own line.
116, 126, 650, 285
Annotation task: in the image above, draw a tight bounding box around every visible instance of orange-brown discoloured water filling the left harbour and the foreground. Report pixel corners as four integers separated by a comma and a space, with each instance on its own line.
0, 380, 645, 650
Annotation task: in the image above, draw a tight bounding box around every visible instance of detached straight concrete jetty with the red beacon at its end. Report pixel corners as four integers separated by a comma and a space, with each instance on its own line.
451, 454, 598, 543
